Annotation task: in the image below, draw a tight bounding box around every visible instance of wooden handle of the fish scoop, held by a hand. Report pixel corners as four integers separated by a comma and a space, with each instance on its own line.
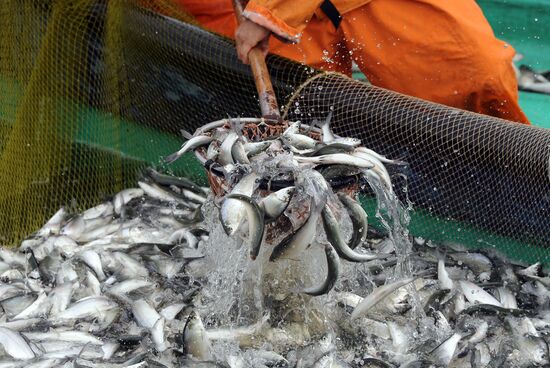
233, 0, 281, 121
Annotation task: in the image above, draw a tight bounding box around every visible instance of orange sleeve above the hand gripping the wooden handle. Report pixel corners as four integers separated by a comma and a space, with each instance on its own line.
243, 0, 323, 43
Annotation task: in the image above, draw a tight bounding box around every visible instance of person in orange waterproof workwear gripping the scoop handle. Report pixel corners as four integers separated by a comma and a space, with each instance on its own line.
173, 0, 529, 124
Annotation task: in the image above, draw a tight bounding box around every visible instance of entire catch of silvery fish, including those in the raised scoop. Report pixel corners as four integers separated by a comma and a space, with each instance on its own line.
0, 117, 550, 368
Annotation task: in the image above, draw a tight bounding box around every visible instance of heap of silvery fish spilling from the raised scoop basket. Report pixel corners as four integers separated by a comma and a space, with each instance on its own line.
166, 112, 401, 295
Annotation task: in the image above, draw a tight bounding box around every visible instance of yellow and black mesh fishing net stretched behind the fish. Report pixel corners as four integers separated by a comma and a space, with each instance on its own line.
0, 0, 550, 261
